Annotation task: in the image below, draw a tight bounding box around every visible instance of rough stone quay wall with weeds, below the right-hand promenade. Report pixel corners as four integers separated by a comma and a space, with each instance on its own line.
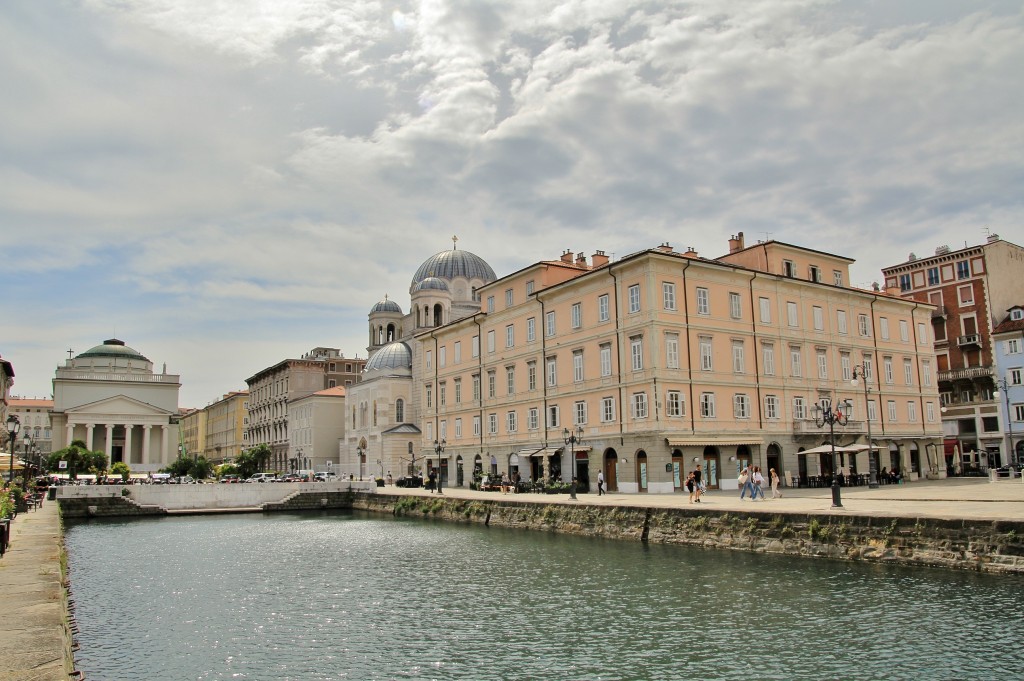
353, 495, 1024, 574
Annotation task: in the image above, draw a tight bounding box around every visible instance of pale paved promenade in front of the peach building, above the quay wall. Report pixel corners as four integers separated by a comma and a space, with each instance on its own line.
378, 478, 1024, 521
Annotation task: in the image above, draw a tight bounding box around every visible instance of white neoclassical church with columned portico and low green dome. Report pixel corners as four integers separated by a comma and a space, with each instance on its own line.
51, 338, 181, 473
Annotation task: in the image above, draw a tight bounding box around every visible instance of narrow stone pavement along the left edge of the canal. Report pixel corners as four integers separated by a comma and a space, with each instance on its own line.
0, 501, 69, 681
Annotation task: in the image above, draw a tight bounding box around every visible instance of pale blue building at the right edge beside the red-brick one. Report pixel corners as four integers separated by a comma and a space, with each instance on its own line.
992, 305, 1024, 468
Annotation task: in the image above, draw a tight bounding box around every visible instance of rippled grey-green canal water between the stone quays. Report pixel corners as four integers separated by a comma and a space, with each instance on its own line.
66, 512, 1024, 681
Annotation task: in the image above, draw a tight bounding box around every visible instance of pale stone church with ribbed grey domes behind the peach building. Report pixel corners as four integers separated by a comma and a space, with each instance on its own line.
339, 240, 498, 481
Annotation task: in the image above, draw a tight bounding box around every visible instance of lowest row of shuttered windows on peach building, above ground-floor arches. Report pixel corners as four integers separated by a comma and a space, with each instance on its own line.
419, 390, 937, 440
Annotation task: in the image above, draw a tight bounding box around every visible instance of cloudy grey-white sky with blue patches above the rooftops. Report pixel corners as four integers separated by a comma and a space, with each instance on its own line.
0, 0, 1024, 408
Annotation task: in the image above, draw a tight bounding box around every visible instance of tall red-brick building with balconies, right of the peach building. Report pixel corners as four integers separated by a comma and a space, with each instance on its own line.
882, 235, 1024, 470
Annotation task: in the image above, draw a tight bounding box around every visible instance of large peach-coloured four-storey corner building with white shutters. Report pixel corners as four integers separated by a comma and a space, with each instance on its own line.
417, 233, 944, 493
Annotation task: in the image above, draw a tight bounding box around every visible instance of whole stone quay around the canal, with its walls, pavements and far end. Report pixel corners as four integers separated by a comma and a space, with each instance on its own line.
0, 479, 1024, 681
